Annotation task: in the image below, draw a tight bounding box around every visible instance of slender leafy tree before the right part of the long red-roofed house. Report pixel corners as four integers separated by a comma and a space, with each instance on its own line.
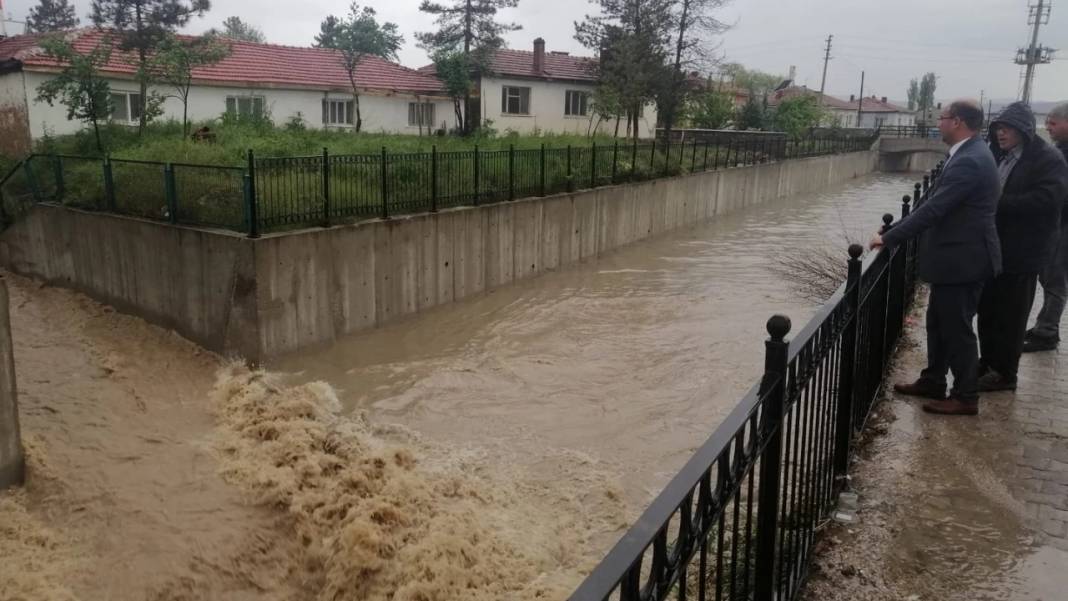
315, 2, 404, 131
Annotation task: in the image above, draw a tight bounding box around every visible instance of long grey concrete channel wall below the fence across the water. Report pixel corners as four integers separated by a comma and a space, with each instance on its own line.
0, 151, 878, 361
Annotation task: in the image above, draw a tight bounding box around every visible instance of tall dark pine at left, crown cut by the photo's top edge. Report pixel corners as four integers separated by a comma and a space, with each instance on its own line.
92, 0, 211, 133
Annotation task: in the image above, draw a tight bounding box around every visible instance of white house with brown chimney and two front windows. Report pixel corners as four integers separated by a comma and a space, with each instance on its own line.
420, 37, 657, 138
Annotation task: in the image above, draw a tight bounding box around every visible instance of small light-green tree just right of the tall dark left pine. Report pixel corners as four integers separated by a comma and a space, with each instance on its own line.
148, 35, 230, 137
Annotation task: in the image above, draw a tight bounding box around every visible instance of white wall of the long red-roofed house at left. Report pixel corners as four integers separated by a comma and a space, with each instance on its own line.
18, 72, 456, 139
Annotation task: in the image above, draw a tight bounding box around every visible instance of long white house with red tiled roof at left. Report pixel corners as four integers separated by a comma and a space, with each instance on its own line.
0, 29, 455, 154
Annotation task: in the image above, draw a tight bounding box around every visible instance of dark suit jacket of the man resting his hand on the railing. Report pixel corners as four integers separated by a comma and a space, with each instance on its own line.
882, 136, 1002, 284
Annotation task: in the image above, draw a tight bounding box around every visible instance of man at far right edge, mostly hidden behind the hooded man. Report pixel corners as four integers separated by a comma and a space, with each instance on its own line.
1023, 102, 1068, 352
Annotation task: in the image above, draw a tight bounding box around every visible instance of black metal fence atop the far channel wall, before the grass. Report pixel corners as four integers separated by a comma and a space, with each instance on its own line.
0, 132, 875, 237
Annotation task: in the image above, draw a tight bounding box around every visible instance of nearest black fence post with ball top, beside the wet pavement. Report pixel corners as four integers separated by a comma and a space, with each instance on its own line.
756, 315, 790, 601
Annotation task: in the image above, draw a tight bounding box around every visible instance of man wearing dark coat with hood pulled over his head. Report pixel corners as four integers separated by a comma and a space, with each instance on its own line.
979, 102, 1068, 391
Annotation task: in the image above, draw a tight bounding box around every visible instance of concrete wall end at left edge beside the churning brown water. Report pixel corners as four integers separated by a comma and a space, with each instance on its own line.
0, 279, 25, 490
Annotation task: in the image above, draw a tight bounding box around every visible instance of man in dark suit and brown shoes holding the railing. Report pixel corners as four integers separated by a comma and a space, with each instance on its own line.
870, 100, 1001, 415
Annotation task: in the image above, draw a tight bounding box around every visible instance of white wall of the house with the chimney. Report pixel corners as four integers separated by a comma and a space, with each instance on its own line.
480, 77, 657, 138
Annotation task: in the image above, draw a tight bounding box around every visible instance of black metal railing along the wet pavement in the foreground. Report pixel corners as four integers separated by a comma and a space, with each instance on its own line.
570, 161, 938, 601
